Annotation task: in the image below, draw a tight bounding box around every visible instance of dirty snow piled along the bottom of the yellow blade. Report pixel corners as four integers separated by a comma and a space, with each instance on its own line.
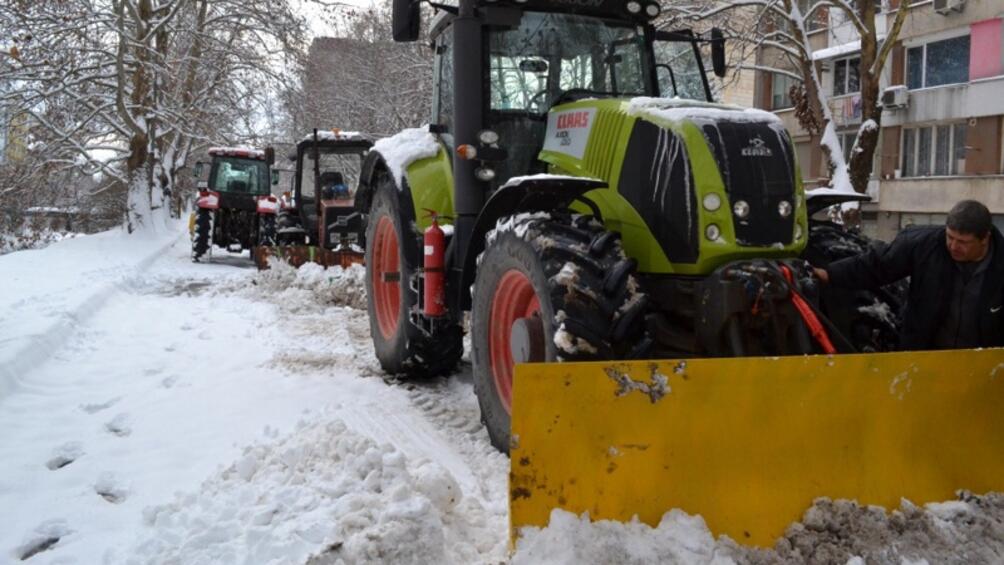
513, 492, 1004, 565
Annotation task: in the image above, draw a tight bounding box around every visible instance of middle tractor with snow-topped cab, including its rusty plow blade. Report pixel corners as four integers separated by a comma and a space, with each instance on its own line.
255, 129, 372, 269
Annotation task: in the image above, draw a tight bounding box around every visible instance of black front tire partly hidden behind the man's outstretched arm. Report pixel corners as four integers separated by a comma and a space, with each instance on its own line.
803, 222, 907, 352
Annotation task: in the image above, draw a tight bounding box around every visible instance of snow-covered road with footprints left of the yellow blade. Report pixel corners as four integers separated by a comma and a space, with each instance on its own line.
0, 230, 508, 563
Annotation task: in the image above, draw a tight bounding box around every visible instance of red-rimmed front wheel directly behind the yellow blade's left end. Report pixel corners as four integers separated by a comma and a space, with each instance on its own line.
471, 214, 652, 453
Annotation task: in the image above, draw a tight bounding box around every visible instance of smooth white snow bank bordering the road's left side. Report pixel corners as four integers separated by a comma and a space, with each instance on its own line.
0, 223, 182, 401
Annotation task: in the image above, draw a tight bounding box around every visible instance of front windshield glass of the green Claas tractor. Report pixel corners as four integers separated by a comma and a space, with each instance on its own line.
488, 12, 655, 114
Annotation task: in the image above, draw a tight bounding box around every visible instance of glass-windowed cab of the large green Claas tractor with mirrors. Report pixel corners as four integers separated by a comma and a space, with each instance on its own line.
421, 1, 725, 190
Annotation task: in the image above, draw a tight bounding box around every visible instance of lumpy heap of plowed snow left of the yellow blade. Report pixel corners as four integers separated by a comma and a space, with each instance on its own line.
136, 418, 495, 564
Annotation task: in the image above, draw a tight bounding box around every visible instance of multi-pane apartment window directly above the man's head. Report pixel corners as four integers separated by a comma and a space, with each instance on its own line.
901, 121, 966, 177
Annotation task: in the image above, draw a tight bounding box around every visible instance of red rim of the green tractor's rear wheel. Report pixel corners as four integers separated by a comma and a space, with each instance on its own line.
372, 216, 401, 339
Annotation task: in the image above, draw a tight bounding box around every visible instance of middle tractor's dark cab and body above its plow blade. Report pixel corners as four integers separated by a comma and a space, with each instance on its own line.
277, 129, 372, 249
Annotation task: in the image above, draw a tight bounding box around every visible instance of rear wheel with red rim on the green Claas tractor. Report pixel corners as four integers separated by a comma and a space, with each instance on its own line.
365, 178, 464, 377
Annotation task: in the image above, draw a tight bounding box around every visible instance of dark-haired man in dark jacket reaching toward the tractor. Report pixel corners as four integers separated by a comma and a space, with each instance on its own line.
814, 200, 1004, 350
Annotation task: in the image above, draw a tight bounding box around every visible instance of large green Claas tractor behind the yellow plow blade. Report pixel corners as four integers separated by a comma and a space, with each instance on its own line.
355, 0, 849, 451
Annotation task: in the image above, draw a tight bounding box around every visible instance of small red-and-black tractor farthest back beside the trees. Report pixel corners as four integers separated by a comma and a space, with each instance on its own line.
190, 148, 279, 262
